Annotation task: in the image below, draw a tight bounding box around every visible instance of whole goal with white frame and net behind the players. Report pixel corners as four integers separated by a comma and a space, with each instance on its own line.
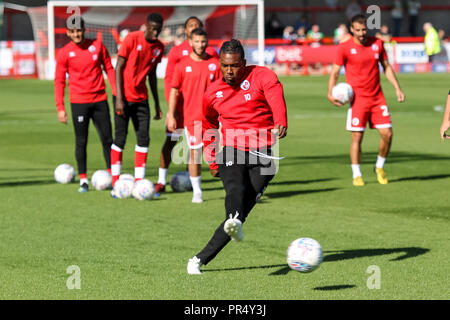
41, 0, 264, 79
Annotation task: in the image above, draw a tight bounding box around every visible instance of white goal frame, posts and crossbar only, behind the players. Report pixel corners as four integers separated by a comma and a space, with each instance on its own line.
47, 0, 264, 72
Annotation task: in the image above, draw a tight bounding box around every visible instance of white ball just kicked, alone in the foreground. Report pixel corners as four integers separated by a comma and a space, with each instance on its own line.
287, 238, 323, 272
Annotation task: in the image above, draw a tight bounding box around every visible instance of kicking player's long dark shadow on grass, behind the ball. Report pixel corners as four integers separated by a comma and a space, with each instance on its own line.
269, 247, 430, 276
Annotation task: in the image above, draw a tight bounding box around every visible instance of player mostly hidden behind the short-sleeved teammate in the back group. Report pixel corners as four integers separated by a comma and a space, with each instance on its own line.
155, 17, 219, 193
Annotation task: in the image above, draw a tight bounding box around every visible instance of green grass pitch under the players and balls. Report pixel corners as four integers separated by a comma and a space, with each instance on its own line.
0, 74, 450, 300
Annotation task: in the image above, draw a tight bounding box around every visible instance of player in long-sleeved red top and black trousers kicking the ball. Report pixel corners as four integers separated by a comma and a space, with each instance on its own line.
187, 39, 287, 274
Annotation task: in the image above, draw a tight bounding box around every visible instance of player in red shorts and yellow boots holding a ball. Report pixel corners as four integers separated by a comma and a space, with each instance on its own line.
328, 14, 405, 186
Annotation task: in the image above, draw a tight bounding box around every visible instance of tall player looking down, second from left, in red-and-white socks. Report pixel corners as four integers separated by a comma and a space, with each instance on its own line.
111, 13, 164, 192
